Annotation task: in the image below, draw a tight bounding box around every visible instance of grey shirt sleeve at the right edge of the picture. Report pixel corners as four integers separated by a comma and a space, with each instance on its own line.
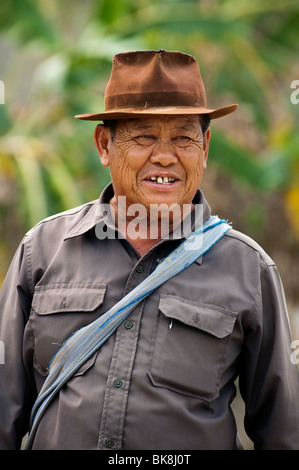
239, 265, 299, 450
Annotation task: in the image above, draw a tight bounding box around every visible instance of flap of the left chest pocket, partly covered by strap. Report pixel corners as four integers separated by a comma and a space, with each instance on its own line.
32, 284, 106, 315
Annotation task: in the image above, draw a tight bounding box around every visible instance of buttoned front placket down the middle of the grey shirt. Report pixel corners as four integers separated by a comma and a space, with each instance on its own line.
98, 260, 151, 449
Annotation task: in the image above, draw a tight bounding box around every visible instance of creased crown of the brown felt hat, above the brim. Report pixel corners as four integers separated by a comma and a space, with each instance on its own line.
105, 50, 206, 112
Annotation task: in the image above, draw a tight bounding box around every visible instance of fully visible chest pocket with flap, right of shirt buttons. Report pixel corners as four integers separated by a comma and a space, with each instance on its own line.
148, 296, 237, 401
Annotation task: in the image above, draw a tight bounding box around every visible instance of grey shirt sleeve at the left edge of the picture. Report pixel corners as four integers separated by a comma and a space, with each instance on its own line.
0, 243, 33, 450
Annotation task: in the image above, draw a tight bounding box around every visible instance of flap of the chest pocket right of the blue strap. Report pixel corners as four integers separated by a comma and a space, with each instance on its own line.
159, 296, 238, 338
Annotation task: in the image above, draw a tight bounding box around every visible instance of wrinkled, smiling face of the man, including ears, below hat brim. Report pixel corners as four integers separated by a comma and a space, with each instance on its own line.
96, 115, 210, 210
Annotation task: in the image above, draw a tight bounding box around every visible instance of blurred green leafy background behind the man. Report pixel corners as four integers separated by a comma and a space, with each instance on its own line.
0, 0, 299, 338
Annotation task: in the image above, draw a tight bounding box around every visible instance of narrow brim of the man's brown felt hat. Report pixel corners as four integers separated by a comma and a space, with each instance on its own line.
75, 104, 238, 121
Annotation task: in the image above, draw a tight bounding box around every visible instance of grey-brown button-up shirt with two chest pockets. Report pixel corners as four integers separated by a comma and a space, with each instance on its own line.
0, 185, 299, 450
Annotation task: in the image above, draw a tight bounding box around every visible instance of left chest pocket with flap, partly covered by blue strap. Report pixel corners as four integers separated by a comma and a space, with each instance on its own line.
29, 284, 106, 375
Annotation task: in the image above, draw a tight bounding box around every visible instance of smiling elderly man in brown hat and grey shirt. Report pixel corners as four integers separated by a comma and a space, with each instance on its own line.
0, 50, 299, 450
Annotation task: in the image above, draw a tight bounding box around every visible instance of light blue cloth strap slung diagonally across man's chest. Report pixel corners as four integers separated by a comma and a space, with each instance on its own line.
26, 216, 231, 449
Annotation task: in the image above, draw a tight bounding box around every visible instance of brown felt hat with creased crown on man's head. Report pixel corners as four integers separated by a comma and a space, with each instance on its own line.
75, 50, 238, 121
